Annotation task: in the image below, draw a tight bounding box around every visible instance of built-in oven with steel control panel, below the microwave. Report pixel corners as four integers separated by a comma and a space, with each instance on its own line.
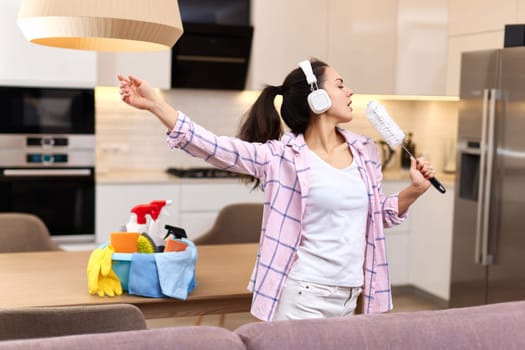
0, 135, 95, 242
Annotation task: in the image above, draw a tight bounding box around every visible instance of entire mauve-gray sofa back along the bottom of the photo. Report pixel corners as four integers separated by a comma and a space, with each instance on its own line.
0, 301, 525, 350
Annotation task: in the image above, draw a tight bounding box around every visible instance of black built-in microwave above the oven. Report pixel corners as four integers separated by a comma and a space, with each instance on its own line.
0, 86, 95, 134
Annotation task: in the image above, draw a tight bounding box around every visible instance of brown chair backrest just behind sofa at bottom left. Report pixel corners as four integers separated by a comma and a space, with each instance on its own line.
0, 304, 147, 340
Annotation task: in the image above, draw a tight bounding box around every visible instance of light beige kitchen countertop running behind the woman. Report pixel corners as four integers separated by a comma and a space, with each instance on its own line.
96, 169, 456, 187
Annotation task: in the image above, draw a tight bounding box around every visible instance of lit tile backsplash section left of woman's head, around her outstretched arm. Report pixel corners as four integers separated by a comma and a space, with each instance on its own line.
96, 88, 254, 171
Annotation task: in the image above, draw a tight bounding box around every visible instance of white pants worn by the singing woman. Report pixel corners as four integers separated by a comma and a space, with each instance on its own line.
272, 278, 361, 321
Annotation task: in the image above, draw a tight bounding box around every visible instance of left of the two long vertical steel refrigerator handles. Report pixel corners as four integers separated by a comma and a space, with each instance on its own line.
474, 89, 490, 264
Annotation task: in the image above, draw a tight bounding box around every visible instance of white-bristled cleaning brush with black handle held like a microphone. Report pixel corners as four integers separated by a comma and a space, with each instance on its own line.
365, 101, 446, 193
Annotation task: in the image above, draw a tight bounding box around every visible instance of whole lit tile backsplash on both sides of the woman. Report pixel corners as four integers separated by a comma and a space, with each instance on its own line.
96, 88, 458, 172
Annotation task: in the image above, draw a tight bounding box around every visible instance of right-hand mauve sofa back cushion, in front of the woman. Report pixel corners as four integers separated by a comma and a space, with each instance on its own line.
235, 302, 525, 350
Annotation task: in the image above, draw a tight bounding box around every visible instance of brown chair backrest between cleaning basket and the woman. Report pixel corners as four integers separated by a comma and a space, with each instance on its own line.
194, 203, 264, 244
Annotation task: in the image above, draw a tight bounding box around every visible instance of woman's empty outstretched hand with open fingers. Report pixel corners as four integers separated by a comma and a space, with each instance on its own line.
118, 75, 160, 111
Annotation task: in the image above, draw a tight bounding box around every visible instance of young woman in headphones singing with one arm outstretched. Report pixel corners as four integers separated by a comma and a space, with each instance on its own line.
119, 60, 434, 320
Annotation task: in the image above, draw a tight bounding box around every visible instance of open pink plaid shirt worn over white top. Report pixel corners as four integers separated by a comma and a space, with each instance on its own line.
168, 112, 406, 320
